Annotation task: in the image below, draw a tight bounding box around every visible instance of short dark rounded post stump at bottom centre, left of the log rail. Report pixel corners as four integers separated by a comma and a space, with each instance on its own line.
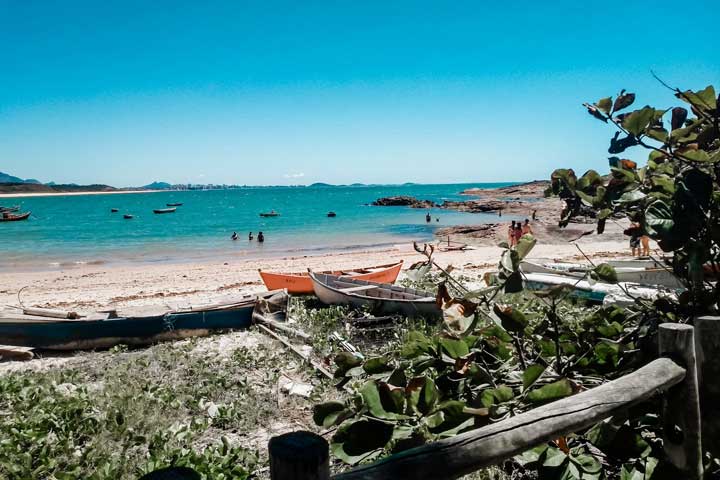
268, 431, 330, 480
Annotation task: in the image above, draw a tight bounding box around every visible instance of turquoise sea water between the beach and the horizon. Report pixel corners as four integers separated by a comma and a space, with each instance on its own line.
0, 183, 511, 270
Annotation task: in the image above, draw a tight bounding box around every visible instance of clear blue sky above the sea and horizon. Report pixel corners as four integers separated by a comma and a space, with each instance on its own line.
0, 0, 720, 186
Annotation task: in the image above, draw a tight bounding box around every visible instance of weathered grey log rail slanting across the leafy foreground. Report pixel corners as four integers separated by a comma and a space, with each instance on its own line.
332, 358, 685, 480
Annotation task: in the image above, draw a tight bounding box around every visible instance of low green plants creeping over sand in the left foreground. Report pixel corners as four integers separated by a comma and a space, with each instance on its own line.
0, 341, 319, 480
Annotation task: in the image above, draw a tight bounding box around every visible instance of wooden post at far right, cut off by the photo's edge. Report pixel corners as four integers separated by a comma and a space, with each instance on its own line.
695, 316, 720, 458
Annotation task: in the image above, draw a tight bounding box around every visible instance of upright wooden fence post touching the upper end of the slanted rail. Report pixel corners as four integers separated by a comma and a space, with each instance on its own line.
658, 323, 703, 479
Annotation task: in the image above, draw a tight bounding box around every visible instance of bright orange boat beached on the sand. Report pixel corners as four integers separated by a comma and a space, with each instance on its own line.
258, 261, 402, 295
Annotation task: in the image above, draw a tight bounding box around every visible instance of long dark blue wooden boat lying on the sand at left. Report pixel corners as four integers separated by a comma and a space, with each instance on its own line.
0, 292, 287, 350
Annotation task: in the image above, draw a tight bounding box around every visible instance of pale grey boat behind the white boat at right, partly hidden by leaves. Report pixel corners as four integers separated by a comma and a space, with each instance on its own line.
520, 261, 684, 289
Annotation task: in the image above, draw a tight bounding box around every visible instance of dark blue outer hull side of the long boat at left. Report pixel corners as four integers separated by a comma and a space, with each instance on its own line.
0, 302, 255, 350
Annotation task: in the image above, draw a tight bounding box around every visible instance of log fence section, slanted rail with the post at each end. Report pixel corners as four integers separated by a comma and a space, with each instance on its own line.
269, 324, 702, 480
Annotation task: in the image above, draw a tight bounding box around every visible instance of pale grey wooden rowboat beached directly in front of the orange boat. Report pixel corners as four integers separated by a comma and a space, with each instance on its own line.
310, 272, 442, 317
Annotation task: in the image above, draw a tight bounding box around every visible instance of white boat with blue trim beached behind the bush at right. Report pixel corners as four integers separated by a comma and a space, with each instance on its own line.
523, 273, 676, 305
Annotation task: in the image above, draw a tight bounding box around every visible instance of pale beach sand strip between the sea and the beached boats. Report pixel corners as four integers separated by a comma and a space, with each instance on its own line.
0, 235, 627, 312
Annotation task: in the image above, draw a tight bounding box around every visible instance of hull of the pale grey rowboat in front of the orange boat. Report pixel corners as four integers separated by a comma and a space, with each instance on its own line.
310, 274, 442, 318
